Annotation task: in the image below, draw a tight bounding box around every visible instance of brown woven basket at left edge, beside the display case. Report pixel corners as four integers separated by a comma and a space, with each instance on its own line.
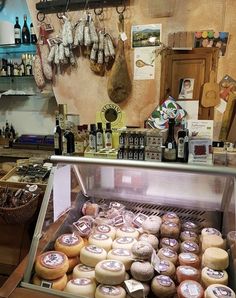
0, 194, 40, 224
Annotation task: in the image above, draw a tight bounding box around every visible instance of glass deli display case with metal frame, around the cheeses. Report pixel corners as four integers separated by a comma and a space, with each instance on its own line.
20, 156, 236, 297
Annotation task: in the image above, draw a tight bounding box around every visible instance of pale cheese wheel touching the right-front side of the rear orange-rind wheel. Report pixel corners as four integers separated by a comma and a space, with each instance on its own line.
80, 245, 107, 267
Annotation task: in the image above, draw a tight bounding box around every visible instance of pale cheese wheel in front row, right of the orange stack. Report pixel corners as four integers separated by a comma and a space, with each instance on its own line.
64, 278, 96, 298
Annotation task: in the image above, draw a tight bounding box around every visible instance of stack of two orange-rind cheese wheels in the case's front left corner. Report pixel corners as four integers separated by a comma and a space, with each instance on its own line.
33, 251, 69, 290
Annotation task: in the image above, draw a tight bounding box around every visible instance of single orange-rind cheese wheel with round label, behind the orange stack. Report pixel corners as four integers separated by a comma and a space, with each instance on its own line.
54, 234, 84, 258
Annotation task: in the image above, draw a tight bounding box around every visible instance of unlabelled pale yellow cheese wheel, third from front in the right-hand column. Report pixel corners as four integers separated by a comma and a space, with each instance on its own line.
202, 247, 229, 270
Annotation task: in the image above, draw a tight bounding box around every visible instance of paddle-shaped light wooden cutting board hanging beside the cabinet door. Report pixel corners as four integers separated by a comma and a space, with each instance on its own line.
201, 70, 220, 108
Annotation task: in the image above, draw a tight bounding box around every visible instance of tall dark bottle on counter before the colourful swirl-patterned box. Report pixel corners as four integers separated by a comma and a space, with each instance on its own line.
163, 118, 177, 162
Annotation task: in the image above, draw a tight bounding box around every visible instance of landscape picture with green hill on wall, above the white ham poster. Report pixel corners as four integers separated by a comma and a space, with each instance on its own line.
131, 24, 161, 48
